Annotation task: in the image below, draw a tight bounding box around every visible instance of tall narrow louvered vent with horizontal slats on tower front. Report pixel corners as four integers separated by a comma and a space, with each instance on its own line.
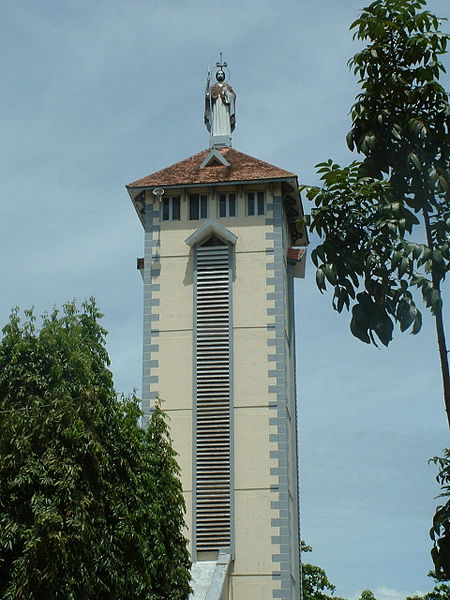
195, 237, 231, 552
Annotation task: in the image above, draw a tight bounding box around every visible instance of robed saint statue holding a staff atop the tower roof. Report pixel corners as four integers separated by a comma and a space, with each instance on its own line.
205, 69, 236, 146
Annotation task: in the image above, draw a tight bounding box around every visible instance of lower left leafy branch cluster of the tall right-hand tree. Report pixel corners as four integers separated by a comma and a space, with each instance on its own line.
302, 161, 426, 346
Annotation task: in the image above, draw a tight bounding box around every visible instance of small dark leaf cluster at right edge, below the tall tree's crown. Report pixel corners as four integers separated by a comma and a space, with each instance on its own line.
427, 449, 450, 580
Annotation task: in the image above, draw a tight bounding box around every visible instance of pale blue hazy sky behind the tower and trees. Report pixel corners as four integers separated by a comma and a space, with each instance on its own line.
0, 0, 450, 600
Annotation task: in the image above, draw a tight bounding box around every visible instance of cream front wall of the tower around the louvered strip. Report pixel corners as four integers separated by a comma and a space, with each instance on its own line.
146, 186, 295, 600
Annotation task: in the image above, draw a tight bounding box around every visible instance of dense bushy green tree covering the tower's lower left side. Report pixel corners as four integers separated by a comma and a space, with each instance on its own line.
0, 300, 190, 600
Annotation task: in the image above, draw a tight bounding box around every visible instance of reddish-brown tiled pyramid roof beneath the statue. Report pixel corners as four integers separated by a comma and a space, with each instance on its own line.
127, 148, 295, 188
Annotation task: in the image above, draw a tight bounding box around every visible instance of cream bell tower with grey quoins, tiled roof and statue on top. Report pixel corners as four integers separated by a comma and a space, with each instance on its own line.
127, 63, 306, 600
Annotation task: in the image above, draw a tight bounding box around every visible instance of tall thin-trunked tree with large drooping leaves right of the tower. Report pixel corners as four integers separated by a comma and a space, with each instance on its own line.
303, 0, 450, 426
